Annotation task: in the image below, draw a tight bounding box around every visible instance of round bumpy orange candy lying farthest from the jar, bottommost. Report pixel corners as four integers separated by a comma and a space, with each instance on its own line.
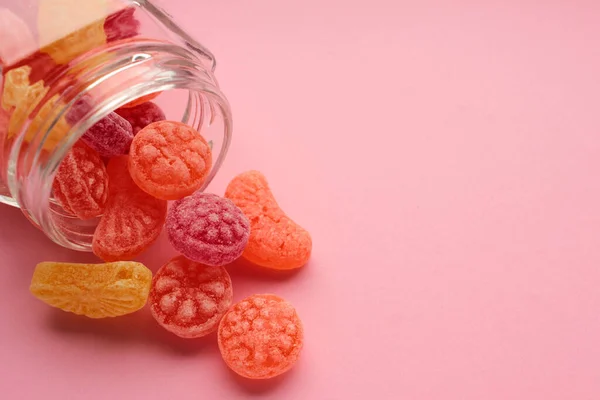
218, 294, 304, 379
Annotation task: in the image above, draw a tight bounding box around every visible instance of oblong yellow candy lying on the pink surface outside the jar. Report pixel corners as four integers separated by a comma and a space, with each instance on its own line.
29, 262, 152, 318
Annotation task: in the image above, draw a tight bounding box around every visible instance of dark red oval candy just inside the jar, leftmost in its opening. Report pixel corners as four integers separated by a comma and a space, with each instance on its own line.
52, 142, 108, 219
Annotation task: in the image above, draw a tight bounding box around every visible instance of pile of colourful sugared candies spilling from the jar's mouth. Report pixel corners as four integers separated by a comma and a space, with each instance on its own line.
23, 92, 312, 379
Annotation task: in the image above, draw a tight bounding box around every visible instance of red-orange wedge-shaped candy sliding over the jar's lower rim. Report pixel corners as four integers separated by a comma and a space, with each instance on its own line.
92, 156, 167, 261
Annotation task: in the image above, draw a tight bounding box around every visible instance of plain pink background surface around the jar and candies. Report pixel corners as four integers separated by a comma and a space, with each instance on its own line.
0, 0, 600, 400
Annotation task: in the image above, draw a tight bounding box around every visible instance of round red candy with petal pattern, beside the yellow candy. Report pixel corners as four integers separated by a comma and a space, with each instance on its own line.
149, 256, 233, 338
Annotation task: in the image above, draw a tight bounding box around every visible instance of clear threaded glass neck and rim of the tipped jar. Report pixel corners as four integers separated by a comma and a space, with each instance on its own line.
7, 39, 232, 251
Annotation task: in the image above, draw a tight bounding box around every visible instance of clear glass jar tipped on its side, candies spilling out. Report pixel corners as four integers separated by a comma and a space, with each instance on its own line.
0, 0, 232, 251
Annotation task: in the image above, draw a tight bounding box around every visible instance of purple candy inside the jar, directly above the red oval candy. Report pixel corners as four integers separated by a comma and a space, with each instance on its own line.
81, 112, 133, 157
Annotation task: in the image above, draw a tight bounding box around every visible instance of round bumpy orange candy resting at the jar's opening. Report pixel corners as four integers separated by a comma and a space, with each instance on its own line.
129, 121, 212, 200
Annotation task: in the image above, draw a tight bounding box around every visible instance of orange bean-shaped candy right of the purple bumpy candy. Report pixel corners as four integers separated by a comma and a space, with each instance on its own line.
225, 171, 312, 269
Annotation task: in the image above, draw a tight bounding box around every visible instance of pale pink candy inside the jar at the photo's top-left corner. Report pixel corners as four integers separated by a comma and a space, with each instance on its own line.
0, 8, 37, 65
